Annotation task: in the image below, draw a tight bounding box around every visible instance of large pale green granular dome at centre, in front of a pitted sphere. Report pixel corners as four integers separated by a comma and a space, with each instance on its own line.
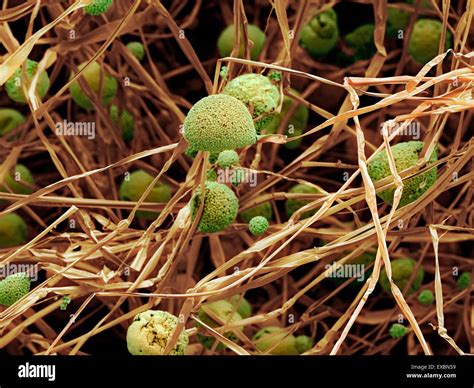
184, 94, 257, 153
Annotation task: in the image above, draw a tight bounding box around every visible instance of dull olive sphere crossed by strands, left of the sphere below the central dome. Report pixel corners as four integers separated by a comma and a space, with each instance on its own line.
119, 170, 172, 219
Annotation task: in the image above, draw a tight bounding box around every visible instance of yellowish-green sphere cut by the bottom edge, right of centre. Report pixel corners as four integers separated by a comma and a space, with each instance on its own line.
252, 326, 299, 356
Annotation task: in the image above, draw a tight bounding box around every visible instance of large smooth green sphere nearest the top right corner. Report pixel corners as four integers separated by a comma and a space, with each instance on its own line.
408, 19, 452, 65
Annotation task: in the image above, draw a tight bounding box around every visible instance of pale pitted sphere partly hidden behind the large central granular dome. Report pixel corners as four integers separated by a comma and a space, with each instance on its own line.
223, 73, 280, 132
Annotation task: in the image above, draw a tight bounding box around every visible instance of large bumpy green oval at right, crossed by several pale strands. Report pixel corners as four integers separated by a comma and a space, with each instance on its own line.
367, 141, 438, 207
